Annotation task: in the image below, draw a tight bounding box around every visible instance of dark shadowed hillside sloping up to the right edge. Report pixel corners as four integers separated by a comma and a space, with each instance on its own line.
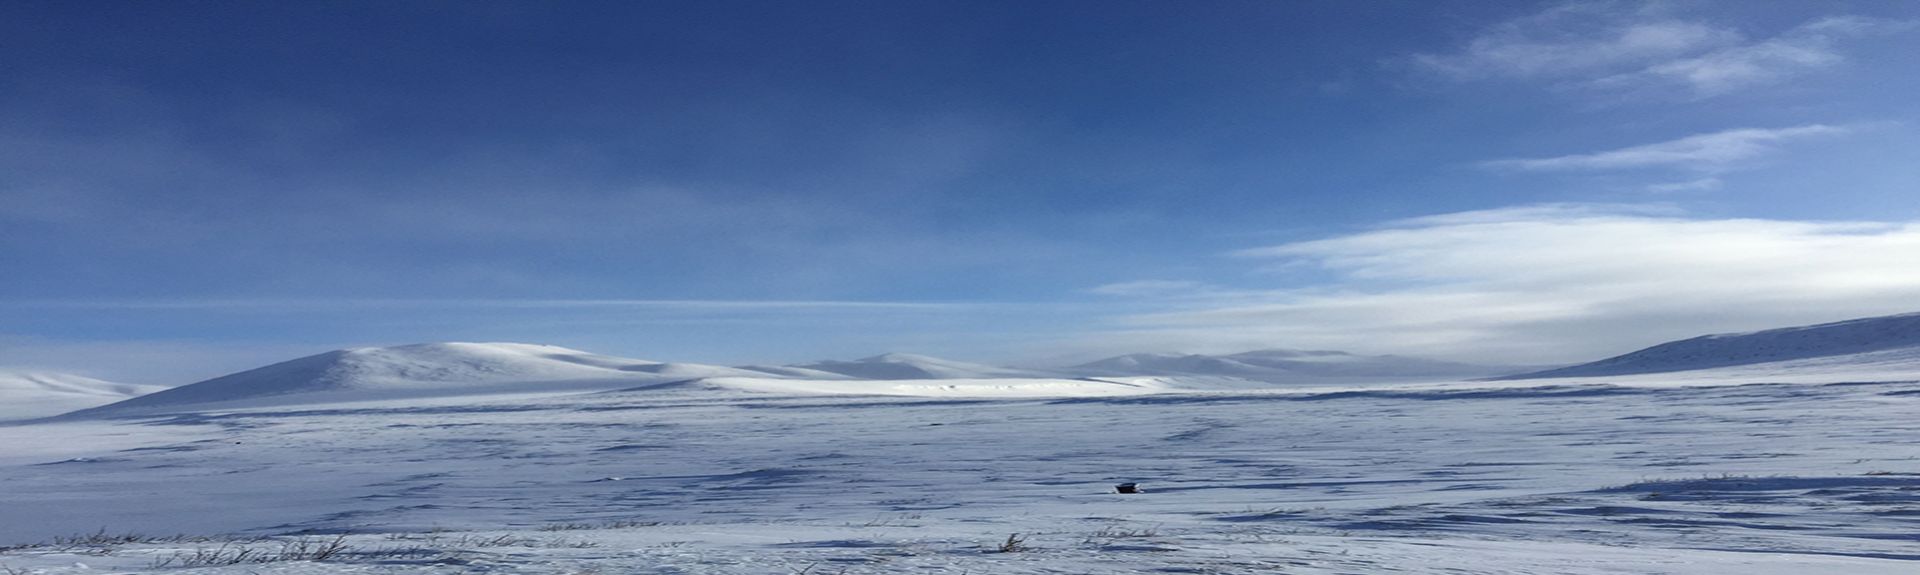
1500, 313, 1920, 379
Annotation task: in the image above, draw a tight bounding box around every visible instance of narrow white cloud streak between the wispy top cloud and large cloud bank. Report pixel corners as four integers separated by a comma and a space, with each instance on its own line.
1482, 123, 1849, 171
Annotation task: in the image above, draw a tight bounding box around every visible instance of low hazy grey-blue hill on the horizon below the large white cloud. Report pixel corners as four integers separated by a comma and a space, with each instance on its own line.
1071, 350, 1511, 383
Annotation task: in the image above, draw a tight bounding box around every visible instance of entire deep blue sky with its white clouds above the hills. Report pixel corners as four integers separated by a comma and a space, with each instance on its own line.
0, 0, 1920, 383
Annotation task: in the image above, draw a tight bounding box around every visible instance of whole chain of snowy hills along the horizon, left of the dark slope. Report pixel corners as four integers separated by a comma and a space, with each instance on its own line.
60, 342, 1543, 417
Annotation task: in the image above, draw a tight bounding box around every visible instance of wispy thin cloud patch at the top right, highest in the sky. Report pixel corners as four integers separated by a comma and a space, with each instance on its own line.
1407, 2, 1912, 98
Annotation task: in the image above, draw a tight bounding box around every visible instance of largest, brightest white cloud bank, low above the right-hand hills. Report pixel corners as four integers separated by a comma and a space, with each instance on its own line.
1102, 206, 1920, 363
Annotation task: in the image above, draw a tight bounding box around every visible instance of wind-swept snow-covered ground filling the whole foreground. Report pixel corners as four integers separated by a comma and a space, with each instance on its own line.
0, 344, 1920, 575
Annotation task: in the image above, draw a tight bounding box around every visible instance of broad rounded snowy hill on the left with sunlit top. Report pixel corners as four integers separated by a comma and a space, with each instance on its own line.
60, 342, 702, 415
